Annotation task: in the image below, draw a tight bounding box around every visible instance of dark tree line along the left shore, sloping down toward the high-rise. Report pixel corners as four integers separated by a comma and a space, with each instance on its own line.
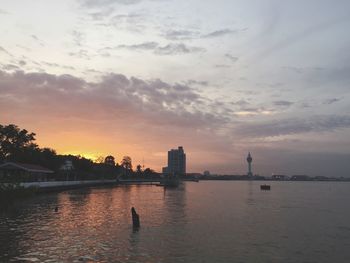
0, 124, 159, 180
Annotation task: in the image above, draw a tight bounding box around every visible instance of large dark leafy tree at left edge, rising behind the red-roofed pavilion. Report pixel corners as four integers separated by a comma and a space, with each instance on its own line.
0, 124, 38, 160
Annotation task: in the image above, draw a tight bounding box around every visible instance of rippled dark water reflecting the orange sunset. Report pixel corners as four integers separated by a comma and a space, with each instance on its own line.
0, 181, 350, 263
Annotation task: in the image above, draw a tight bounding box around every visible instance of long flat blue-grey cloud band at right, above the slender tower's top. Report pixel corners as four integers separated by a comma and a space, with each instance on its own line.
235, 115, 350, 137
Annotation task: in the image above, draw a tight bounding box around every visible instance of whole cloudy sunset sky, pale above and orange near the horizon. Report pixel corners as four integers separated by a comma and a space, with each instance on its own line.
0, 0, 350, 177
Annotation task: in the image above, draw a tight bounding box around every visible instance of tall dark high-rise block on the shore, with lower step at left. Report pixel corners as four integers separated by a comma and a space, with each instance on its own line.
163, 146, 186, 175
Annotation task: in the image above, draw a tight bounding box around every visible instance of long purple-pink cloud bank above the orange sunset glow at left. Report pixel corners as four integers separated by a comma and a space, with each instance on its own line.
0, 71, 226, 127
